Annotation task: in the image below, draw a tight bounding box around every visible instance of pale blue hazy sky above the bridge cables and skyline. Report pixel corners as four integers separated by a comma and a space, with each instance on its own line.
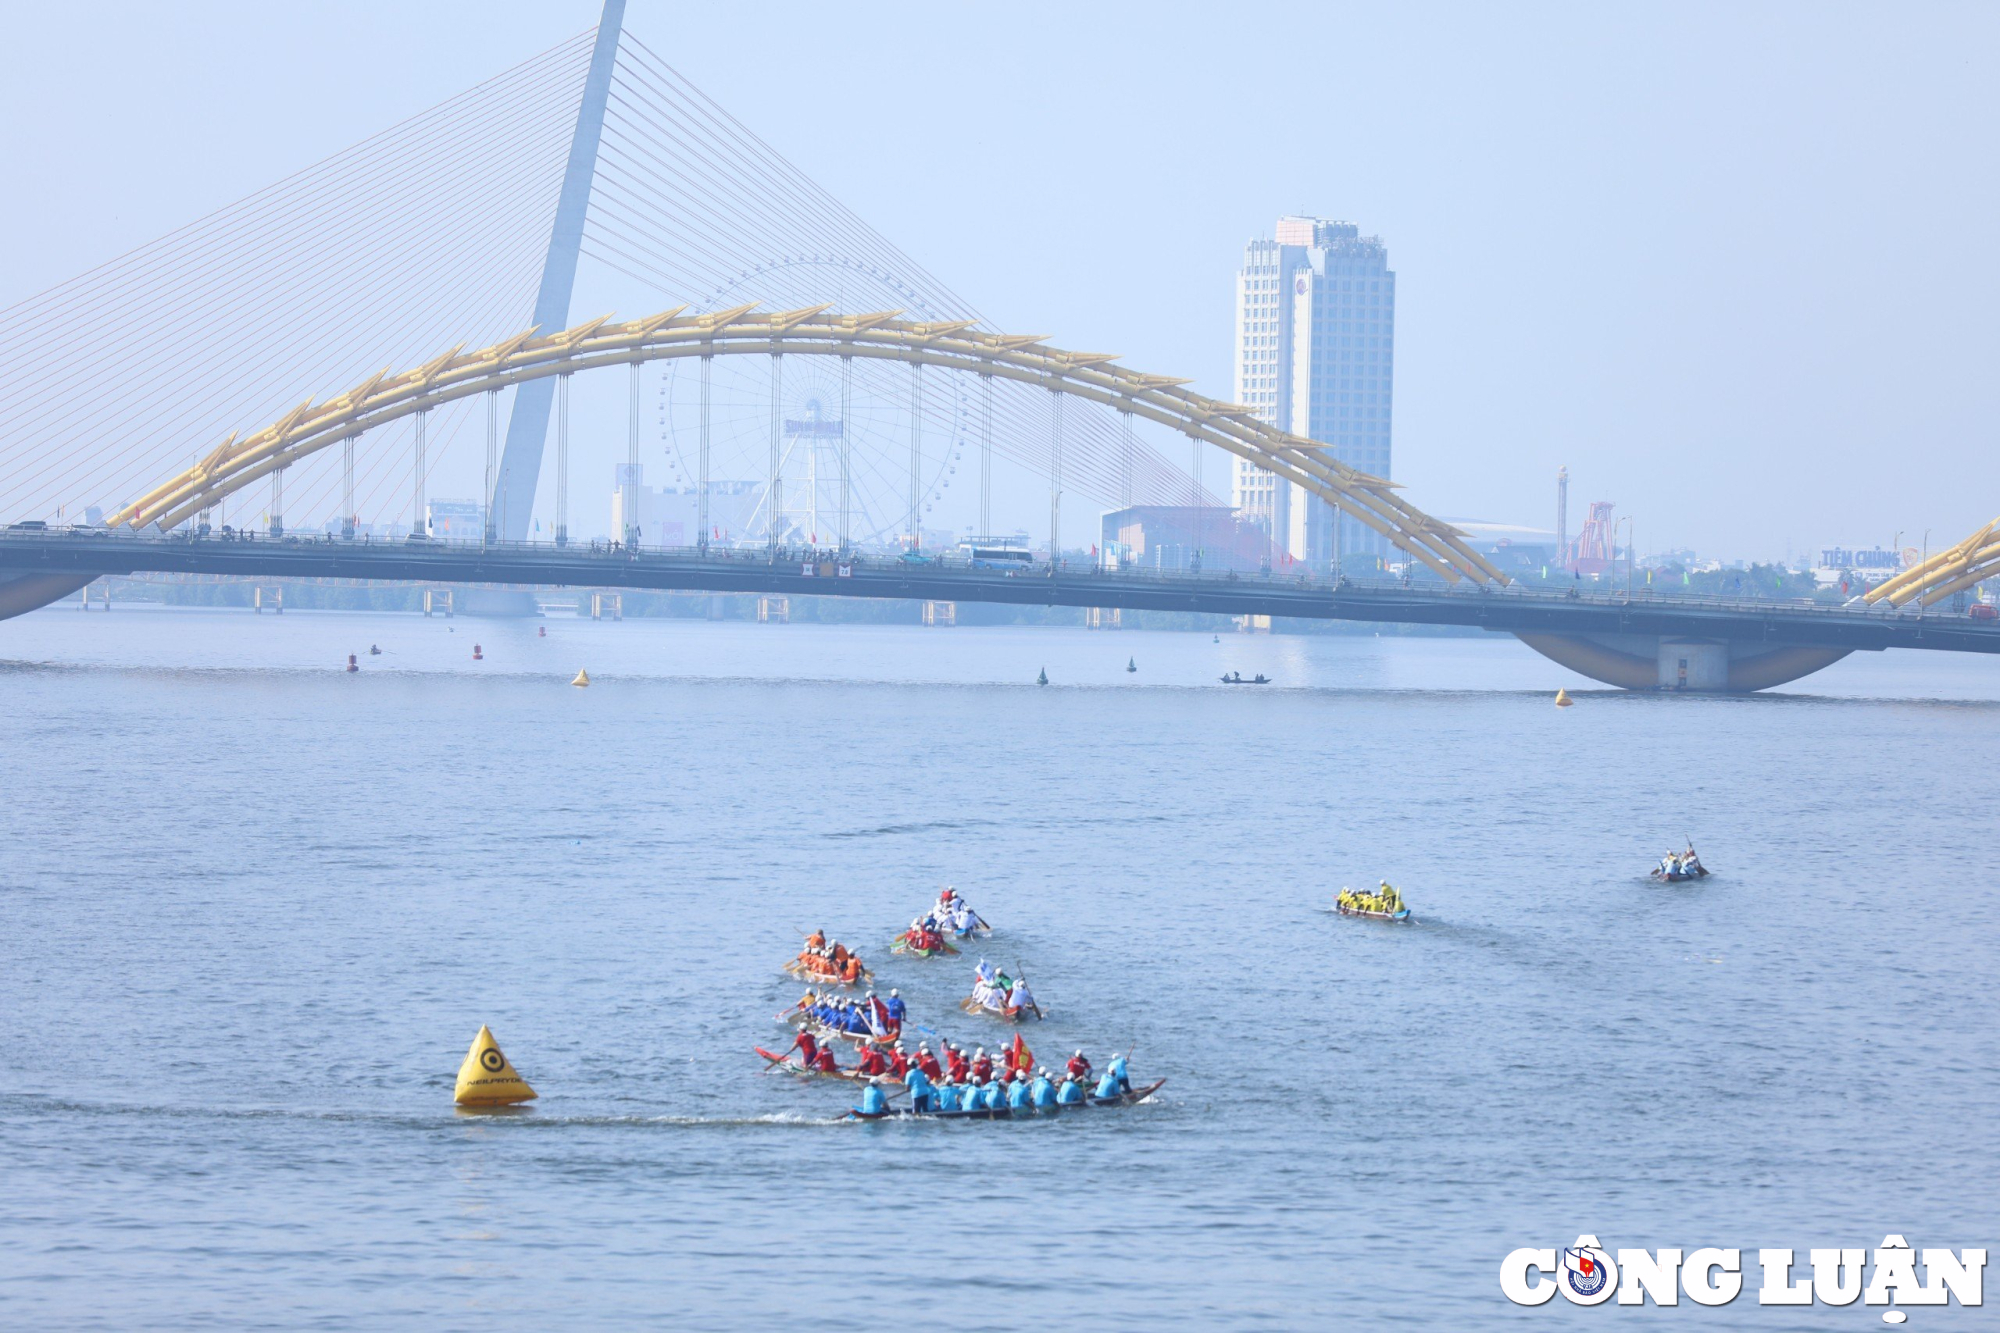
0, 0, 2000, 556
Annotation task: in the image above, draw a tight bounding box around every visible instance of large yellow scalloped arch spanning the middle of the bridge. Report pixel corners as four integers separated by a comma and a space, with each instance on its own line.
110, 306, 1508, 584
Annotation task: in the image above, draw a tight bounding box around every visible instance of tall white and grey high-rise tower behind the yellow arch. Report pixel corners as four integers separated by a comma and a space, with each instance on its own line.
1234, 218, 1396, 566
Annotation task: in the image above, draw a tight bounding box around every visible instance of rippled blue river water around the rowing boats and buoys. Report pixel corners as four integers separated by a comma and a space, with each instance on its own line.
0, 606, 2000, 1329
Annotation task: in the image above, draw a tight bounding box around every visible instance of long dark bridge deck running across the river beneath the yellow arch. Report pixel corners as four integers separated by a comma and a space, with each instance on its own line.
0, 530, 2000, 652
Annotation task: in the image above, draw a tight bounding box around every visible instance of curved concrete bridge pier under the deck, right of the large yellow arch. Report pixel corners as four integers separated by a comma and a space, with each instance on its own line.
1514, 634, 1852, 695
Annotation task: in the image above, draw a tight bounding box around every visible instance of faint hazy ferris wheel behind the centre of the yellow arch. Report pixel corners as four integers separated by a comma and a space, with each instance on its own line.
658, 256, 980, 546
